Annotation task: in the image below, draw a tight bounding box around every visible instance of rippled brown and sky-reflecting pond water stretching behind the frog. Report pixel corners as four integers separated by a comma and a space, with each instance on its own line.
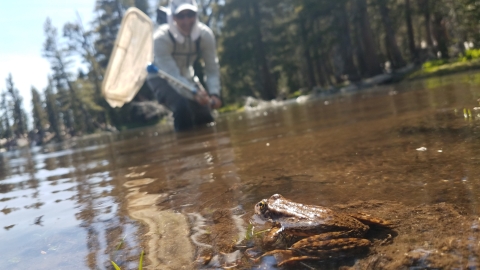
0, 71, 480, 269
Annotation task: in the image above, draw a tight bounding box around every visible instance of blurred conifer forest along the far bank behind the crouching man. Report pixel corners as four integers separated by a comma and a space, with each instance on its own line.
0, 0, 480, 148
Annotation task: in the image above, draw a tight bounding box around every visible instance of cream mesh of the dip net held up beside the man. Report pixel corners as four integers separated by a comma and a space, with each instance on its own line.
102, 8, 153, 107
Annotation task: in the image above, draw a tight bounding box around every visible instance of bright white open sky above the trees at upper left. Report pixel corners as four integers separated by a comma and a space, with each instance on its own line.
0, 0, 95, 115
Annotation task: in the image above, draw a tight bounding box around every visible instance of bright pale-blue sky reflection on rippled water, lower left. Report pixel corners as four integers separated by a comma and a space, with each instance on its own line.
0, 140, 139, 269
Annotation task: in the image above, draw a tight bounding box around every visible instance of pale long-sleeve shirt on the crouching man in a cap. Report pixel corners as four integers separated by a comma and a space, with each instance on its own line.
149, 22, 220, 95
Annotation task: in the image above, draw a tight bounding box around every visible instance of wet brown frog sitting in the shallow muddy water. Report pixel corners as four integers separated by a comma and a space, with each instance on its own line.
255, 194, 391, 266
